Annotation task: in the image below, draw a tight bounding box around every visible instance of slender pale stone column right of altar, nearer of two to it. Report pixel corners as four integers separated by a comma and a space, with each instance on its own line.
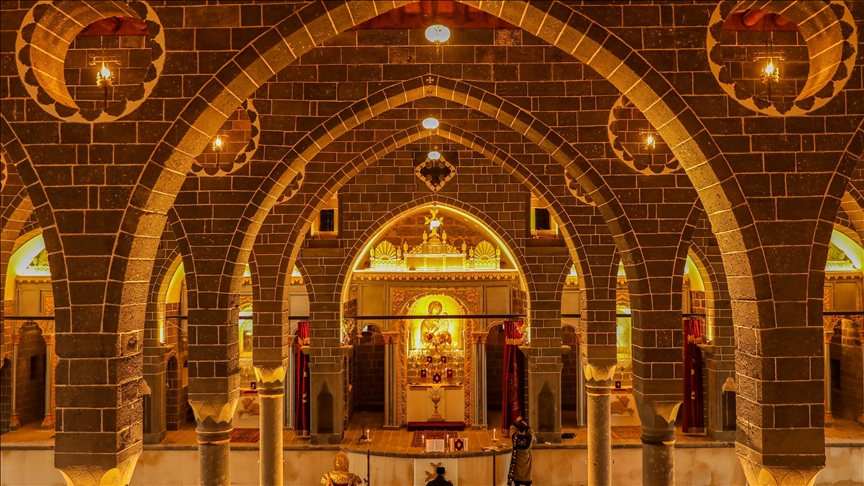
584, 363, 616, 486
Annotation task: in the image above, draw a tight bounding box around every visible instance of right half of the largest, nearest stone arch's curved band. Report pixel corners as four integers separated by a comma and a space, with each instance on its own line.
459, 0, 771, 300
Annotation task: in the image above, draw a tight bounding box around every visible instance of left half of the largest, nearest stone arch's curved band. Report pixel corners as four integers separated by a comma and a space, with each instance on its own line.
112, 0, 418, 308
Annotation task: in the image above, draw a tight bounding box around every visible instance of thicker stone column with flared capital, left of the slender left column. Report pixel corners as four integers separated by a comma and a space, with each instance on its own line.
189, 396, 240, 486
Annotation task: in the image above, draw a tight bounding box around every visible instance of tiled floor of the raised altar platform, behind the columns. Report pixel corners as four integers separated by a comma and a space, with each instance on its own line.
0, 412, 864, 455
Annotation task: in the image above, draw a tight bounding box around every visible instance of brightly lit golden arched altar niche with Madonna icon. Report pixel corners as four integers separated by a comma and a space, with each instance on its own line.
340, 203, 527, 430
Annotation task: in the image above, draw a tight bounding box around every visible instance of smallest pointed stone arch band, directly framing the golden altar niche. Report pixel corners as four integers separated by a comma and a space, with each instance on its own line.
276, 123, 604, 310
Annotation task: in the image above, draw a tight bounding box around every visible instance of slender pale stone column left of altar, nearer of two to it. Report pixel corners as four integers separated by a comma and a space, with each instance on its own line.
255, 365, 285, 486
